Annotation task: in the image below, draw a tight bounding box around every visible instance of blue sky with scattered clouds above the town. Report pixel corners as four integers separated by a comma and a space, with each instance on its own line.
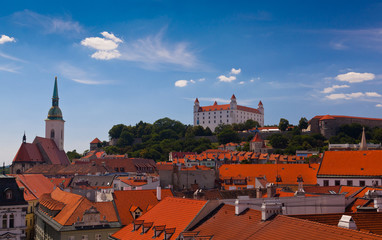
0, 1, 382, 163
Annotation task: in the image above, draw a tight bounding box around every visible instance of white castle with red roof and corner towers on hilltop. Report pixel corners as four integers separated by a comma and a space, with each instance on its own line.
194, 95, 264, 131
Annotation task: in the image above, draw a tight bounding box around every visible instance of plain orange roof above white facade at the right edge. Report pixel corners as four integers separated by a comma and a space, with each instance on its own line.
317, 150, 382, 176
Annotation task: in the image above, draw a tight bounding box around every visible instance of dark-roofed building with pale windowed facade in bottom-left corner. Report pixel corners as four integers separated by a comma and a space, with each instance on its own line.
0, 175, 28, 240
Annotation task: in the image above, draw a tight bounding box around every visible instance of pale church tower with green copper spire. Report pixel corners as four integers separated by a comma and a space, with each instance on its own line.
45, 77, 65, 150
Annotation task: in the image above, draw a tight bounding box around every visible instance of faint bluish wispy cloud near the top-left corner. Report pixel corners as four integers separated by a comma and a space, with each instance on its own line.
12, 10, 83, 34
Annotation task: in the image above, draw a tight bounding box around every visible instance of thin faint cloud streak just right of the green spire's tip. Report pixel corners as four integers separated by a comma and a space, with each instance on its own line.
58, 63, 111, 85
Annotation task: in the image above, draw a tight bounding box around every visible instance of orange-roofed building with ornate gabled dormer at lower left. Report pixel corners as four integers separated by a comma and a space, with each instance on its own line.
35, 188, 121, 240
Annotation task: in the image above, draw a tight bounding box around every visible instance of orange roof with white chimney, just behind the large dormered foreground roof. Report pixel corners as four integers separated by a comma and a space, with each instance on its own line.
113, 189, 173, 225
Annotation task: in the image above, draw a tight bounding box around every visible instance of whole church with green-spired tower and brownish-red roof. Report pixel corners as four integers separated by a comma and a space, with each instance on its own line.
10, 77, 70, 174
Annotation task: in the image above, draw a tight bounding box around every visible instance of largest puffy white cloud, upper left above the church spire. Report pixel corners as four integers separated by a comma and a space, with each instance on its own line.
81, 32, 123, 60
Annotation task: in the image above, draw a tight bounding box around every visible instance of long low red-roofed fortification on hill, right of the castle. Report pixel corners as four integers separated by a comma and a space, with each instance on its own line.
308, 115, 382, 138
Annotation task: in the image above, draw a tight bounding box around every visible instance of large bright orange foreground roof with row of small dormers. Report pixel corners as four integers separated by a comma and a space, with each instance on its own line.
112, 197, 207, 240
